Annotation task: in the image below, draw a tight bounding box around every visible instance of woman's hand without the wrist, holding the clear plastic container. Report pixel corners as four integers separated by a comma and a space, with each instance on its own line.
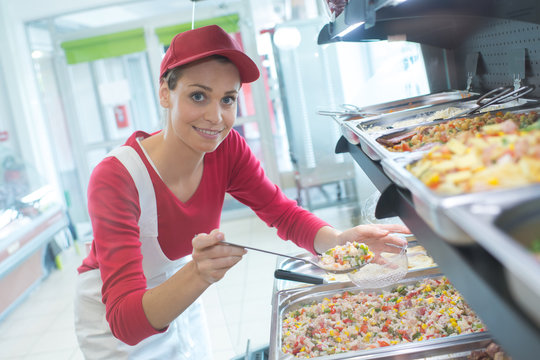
337, 224, 411, 254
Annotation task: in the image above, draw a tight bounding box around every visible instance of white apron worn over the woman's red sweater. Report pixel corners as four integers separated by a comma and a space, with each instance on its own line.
75, 146, 212, 360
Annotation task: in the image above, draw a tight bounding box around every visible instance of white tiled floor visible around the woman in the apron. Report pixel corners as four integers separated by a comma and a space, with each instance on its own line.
0, 204, 358, 360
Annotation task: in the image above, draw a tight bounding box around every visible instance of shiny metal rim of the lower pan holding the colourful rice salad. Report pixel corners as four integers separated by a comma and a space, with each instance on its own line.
269, 272, 491, 360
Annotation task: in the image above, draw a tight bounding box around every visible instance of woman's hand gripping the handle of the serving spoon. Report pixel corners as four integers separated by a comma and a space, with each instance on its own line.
192, 229, 247, 284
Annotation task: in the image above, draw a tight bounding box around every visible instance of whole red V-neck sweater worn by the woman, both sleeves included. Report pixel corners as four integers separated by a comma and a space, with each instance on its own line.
78, 130, 327, 344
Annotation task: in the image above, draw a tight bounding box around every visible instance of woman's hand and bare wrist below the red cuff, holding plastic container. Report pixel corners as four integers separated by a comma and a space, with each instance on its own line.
314, 224, 411, 254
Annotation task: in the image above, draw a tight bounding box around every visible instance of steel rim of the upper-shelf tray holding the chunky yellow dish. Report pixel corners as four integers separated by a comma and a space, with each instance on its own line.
381, 153, 540, 245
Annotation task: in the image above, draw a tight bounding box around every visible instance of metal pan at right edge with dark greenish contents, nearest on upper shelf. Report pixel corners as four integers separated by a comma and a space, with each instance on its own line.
447, 195, 540, 327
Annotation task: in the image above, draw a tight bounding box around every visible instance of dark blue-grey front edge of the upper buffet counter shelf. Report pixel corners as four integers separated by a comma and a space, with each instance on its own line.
336, 137, 540, 359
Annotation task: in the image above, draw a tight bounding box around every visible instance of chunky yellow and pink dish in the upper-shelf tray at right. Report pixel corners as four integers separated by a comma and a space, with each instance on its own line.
407, 115, 540, 195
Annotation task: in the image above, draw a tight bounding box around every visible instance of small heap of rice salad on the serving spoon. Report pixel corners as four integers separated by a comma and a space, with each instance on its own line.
319, 241, 373, 271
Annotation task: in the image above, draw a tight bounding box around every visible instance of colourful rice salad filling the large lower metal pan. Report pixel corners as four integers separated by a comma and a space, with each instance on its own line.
281, 277, 486, 358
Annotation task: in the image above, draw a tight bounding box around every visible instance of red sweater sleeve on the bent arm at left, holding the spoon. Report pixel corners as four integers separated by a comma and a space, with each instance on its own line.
88, 158, 165, 345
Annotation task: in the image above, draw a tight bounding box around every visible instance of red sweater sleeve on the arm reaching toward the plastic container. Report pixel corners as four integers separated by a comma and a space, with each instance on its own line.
224, 132, 329, 254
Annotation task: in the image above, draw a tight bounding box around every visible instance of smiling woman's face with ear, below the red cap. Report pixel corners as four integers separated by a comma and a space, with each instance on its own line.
159, 59, 241, 153
